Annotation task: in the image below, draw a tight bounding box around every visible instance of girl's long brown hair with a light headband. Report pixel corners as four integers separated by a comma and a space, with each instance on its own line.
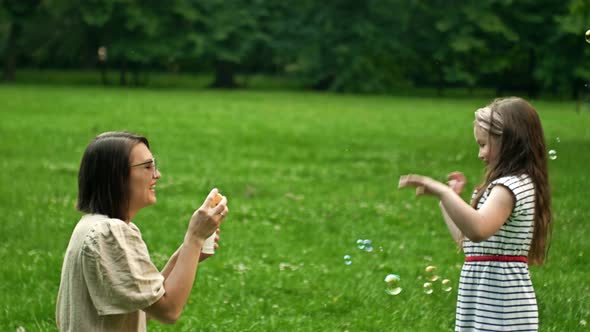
471, 97, 553, 265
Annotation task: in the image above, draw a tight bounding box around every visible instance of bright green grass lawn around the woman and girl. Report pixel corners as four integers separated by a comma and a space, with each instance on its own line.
0, 85, 590, 331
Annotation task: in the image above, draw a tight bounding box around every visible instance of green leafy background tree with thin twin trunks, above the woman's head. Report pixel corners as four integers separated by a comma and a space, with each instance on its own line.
76, 0, 204, 85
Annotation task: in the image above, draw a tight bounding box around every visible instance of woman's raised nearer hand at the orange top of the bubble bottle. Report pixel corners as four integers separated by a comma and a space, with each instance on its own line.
185, 188, 229, 245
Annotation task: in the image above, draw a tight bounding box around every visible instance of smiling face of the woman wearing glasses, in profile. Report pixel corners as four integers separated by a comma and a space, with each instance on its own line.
129, 143, 161, 218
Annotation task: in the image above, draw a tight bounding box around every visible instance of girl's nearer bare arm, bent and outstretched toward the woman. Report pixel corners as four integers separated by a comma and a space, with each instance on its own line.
399, 175, 514, 242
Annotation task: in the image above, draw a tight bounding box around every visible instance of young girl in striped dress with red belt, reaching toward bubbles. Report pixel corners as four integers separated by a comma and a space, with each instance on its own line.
399, 97, 552, 331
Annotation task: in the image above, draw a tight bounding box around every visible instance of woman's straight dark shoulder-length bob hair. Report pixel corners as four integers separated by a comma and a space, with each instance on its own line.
76, 131, 150, 220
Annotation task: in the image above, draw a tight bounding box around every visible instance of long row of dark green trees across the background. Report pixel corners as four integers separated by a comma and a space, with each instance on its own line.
0, 0, 590, 98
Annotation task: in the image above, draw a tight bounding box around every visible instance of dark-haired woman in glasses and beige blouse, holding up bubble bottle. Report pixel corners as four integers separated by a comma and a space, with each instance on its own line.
56, 132, 228, 331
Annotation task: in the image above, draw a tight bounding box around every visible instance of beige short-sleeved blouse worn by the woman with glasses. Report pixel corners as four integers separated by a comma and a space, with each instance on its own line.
56, 214, 165, 331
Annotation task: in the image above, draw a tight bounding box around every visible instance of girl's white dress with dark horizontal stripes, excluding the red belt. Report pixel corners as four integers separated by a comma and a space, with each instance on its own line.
455, 175, 539, 331
